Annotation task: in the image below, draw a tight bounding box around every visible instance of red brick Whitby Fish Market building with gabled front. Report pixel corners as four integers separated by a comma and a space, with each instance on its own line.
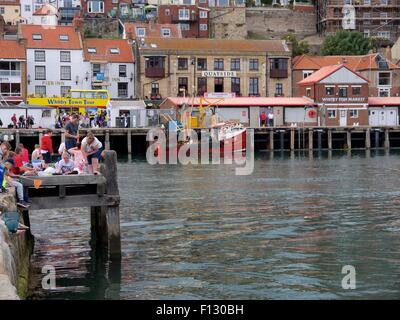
298, 64, 369, 127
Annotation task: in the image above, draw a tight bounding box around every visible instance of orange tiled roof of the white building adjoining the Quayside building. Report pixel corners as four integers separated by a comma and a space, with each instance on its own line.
83, 39, 134, 63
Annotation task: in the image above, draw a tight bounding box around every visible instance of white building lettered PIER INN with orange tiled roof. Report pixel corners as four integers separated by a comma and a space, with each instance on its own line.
20, 25, 90, 97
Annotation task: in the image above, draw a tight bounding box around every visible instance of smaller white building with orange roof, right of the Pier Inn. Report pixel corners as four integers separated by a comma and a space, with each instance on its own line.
84, 39, 136, 99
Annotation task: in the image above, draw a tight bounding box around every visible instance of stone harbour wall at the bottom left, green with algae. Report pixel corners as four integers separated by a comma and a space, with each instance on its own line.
0, 188, 33, 300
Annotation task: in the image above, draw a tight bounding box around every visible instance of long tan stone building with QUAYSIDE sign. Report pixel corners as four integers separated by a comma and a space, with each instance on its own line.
135, 38, 291, 98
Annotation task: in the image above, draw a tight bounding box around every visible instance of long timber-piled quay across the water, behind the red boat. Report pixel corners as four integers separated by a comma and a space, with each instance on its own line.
0, 126, 400, 156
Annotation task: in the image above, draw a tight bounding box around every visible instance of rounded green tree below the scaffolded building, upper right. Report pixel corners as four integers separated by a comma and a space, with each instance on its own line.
321, 30, 372, 56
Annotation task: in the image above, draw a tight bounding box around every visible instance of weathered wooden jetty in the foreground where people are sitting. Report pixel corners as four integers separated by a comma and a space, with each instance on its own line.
21, 151, 121, 261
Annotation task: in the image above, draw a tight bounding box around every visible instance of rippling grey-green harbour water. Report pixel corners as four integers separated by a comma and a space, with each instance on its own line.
30, 151, 400, 299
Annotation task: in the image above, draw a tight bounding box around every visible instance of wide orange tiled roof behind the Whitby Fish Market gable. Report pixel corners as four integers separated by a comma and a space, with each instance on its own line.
292, 53, 398, 71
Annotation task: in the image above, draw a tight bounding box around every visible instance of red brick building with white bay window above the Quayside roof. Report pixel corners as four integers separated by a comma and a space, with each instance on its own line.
158, 5, 209, 38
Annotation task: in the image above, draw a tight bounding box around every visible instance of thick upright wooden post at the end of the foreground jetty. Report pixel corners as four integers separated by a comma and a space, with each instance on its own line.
99, 150, 121, 260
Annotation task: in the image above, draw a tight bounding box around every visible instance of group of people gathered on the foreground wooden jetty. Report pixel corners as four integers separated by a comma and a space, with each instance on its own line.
0, 114, 104, 208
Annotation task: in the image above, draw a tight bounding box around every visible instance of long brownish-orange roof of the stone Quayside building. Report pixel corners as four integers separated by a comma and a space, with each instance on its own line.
141, 38, 290, 54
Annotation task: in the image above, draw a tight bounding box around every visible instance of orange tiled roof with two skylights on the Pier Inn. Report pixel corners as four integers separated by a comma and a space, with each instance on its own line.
20, 24, 82, 50
